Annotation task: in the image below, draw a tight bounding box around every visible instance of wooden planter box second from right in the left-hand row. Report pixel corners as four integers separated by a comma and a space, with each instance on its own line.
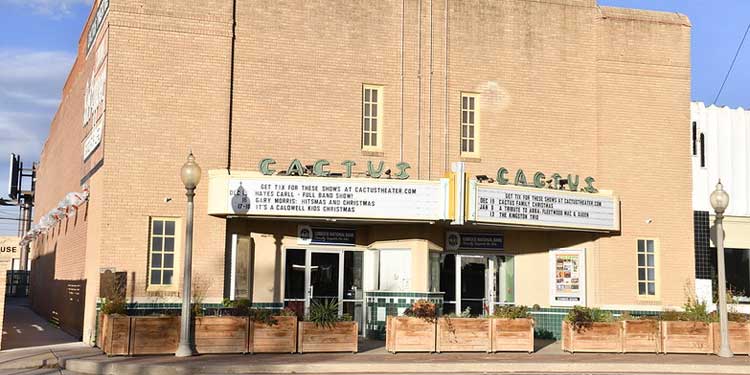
253, 316, 297, 353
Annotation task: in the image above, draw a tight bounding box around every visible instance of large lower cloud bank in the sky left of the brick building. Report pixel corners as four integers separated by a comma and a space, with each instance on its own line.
0, 50, 75, 235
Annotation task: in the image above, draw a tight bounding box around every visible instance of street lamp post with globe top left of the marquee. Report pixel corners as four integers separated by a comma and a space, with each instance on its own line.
174, 151, 201, 357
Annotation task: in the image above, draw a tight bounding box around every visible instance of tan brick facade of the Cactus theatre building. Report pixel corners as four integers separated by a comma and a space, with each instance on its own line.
34, 0, 695, 346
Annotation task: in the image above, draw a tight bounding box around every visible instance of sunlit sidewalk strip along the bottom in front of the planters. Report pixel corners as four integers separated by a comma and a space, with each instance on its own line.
61, 342, 750, 375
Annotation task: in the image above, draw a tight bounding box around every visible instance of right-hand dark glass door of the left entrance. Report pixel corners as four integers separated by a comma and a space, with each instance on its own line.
305, 251, 344, 314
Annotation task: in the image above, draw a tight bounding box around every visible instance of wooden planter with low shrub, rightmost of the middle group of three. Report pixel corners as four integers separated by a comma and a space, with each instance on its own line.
490, 306, 534, 353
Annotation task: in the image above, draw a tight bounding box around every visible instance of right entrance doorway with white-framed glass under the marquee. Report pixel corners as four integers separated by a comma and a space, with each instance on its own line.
440, 254, 515, 315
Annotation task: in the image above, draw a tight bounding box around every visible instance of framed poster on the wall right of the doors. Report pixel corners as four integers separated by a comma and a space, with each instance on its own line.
549, 249, 586, 306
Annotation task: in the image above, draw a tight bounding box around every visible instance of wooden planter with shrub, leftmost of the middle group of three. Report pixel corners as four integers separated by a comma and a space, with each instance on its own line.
385, 300, 437, 353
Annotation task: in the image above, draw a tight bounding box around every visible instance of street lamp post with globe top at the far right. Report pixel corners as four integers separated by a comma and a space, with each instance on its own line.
711, 180, 734, 357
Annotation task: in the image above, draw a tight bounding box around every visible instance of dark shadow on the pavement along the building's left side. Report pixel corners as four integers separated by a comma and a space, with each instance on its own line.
0, 297, 78, 350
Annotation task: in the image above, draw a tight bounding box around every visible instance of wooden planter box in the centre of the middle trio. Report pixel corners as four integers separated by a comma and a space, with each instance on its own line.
435, 318, 492, 353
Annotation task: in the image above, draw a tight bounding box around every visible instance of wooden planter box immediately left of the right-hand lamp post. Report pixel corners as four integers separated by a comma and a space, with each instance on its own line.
661, 321, 714, 354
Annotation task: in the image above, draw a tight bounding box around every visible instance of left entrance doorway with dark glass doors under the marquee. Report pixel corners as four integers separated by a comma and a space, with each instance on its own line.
284, 249, 364, 332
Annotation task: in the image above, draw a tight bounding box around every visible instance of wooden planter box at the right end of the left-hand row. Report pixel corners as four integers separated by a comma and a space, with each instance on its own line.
297, 322, 358, 353
